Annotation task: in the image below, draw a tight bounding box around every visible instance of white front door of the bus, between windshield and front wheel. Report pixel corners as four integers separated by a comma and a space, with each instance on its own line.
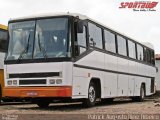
72, 26, 89, 98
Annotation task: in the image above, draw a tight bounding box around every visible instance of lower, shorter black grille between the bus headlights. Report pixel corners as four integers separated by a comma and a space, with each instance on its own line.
19, 79, 47, 85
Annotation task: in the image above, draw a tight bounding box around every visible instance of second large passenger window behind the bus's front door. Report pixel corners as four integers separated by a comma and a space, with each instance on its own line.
104, 30, 116, 53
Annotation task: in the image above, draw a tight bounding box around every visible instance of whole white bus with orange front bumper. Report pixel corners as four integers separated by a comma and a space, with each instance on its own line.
4, 14, 156, 107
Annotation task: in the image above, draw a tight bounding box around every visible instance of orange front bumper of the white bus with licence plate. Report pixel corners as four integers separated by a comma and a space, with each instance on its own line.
3, 86, 72, 98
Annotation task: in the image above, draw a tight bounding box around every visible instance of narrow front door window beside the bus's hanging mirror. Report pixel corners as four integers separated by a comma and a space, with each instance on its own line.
77, 26, 87, 54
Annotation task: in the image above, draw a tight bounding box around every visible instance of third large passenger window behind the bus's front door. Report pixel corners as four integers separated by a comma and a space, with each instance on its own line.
117, 35, 127, 56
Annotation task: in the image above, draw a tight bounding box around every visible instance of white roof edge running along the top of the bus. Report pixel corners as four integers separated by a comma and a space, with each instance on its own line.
10, 12, 154, 50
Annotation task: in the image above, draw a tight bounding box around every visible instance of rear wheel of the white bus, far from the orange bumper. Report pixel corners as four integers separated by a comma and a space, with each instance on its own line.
132, 84, 146, 102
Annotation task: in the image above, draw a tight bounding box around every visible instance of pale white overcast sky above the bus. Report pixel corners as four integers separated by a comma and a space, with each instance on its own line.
0, 0, 160, 54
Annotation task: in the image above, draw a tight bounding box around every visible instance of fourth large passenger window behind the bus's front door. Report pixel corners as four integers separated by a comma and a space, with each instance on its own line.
128, 40, 136, 59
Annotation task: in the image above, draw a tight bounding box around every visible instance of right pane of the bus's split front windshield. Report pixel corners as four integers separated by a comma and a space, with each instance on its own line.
34, 18, 70, 58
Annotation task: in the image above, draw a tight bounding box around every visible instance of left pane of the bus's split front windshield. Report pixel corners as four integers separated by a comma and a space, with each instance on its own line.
7, 21, 35, 60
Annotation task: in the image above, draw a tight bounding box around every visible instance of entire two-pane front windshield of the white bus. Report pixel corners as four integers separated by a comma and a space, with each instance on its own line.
6, 18, 70, 60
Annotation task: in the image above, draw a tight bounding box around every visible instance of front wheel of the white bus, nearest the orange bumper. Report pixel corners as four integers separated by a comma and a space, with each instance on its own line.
83, 82, 97, 107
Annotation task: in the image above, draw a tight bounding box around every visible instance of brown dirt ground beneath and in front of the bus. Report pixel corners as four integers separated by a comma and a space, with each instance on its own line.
0, 97, 160, 120
